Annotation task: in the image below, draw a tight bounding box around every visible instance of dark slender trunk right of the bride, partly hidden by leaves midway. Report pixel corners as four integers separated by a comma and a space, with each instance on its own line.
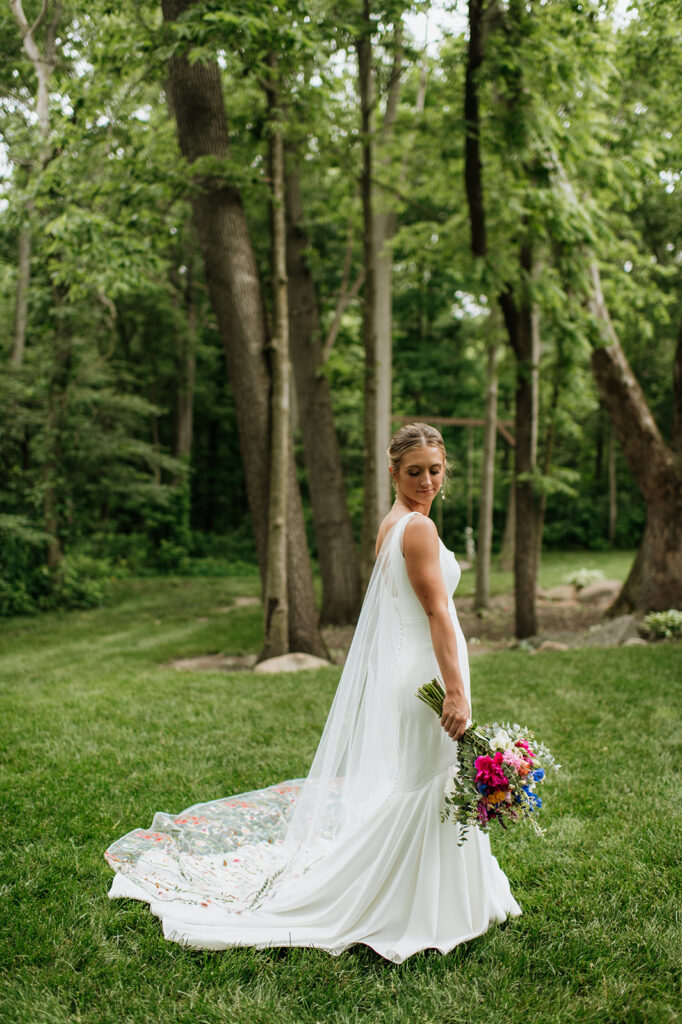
464, 0, 539, 637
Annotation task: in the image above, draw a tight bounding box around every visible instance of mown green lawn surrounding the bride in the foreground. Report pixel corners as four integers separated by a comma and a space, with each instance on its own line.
0, 579, 682, 1024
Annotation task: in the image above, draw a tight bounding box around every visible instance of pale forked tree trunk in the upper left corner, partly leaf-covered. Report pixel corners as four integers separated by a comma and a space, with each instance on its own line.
9, 0, 61, 367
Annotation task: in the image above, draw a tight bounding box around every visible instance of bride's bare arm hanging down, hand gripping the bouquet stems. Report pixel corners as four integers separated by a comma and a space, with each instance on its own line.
402, 516, 471, 739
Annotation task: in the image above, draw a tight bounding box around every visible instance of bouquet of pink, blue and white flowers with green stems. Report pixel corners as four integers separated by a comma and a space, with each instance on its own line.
417, 679, 561, 846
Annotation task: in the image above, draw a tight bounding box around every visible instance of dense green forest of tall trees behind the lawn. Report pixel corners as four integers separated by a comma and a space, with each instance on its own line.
0, 0, 682, 652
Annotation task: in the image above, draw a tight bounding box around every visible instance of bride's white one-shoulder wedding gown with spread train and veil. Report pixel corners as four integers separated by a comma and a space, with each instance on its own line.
105, 513, 521, 963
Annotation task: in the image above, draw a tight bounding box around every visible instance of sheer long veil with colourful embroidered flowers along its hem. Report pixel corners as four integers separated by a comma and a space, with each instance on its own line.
105, 515, 411, 910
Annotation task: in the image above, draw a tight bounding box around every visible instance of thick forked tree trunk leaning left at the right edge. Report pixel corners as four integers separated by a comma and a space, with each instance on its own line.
591, 262, 682, 614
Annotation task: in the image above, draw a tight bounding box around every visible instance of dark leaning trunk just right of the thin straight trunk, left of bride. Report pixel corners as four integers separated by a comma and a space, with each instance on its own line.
286, 159, 361, 626
